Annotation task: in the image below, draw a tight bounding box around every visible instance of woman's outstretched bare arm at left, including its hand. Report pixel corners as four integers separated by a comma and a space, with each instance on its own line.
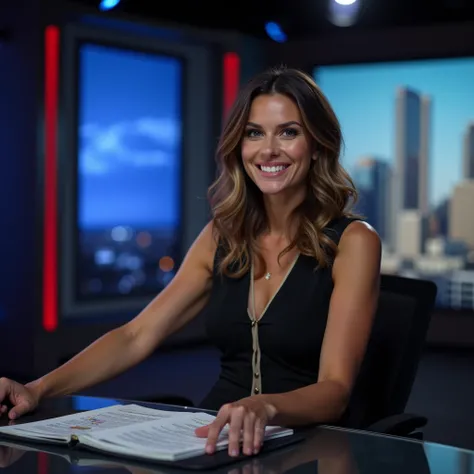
0, 223, 216, 417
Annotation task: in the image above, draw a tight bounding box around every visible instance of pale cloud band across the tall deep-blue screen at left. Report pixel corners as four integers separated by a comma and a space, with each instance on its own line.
79, 117, 181, 174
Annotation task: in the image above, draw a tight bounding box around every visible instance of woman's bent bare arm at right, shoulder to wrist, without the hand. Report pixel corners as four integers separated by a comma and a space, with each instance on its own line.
262, 221, 381, 425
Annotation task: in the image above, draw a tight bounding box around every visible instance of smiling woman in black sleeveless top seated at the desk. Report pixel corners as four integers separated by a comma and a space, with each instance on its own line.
0, 65, 381, 462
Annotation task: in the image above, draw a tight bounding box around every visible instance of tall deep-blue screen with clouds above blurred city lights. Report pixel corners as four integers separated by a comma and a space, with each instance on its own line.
74, 42, 183, 301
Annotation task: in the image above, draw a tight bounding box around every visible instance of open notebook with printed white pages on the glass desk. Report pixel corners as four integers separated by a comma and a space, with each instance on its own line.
0, 404, 293, 462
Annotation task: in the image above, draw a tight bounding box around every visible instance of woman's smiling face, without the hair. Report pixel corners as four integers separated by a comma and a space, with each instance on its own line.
241, 94, 311, 194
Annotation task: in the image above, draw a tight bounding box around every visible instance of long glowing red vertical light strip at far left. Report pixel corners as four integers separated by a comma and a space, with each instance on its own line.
43, 26, 59, 331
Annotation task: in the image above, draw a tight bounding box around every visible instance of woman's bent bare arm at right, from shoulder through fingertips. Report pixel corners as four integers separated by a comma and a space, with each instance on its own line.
197, 221, 381, 455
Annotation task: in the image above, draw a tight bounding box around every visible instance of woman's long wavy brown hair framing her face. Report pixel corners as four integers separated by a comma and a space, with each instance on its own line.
208, 68, 357, 278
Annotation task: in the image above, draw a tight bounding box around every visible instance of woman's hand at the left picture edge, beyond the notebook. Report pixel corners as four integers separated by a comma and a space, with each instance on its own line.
0, 377, 39, 420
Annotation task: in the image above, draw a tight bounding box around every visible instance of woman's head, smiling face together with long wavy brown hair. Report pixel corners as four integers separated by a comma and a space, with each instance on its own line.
209, 66, 356, 276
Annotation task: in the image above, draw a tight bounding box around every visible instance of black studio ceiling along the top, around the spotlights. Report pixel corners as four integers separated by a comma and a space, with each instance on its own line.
69, 0, 474, 39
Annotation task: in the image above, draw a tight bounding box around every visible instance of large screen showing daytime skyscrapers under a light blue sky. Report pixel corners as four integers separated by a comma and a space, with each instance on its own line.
314, 58, 474, 310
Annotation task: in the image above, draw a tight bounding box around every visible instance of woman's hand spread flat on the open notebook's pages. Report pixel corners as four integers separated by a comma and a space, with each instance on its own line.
196, 395, 276, 456
